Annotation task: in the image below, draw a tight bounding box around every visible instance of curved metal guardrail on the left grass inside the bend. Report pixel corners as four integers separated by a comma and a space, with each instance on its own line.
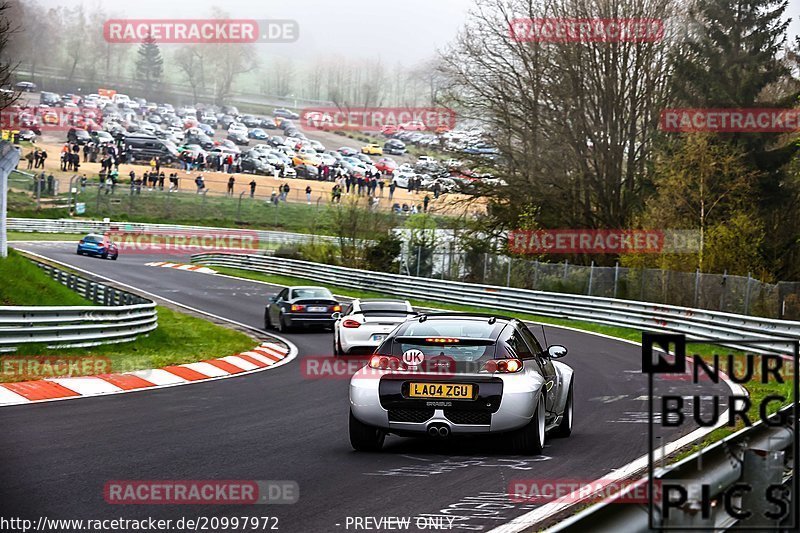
0, 260, 158, 352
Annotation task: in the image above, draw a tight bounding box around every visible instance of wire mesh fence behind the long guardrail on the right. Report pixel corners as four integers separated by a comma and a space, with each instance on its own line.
402, 246, 800, 320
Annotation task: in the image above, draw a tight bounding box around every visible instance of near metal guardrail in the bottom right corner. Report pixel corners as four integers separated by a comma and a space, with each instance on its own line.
552, 406, 800, 533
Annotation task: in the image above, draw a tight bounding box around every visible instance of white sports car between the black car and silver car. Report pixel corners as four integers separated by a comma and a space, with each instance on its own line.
333, 298, 416, 355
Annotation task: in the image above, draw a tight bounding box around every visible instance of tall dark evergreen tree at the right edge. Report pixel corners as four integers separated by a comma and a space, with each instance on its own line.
674, 0, 800, 279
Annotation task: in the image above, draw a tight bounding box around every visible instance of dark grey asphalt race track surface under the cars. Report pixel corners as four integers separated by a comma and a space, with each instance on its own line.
0, 243, 727, 533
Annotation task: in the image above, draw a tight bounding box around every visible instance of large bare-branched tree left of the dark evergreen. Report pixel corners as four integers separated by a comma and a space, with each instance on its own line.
441, 0, 681, 241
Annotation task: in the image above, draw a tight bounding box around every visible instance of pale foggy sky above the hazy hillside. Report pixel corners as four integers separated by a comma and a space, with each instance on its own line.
28, 0, 800, 66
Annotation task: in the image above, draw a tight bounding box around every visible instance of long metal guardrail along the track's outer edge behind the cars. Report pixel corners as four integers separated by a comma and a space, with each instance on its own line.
192, 253, 800, 354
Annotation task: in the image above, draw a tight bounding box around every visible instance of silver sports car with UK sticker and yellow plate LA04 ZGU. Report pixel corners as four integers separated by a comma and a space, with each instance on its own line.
350, 313, 573, 454
